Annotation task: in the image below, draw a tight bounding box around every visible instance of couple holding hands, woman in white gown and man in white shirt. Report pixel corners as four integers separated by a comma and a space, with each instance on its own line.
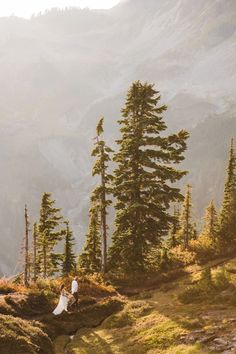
53, 277, 79, 316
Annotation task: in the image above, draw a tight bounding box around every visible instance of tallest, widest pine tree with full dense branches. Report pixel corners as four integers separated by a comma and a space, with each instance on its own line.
109, 81, 188, 273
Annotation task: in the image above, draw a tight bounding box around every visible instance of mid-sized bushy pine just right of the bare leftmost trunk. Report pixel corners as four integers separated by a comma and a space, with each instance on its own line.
38, 193, 62, 278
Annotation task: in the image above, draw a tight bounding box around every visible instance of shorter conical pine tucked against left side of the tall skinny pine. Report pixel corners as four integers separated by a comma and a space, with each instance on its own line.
79, 199, 102, 273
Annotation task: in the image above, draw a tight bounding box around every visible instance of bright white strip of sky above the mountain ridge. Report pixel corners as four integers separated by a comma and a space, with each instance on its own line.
0, 0, 119, 18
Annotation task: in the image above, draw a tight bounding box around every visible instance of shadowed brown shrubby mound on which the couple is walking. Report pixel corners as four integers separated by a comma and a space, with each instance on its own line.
0, 276, 119, 354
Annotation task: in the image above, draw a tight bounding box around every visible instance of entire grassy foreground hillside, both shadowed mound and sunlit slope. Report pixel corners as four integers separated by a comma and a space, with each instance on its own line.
0, 258, 236, 354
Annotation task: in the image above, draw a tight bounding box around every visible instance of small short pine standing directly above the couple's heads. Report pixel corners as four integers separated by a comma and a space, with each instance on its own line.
62, 221, 76, 275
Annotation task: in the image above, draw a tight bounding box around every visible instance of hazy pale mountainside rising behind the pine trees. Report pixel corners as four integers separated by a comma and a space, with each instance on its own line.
0, 0, 236, 274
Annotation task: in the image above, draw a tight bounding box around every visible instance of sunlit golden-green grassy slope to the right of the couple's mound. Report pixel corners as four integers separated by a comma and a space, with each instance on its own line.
54, 259, 236, 354
